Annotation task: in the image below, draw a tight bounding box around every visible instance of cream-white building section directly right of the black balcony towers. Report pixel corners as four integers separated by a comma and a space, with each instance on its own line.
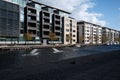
63, 17, 77, 45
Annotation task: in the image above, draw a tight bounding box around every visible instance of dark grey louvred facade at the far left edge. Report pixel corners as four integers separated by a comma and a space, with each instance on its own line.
0, 0, 20, 44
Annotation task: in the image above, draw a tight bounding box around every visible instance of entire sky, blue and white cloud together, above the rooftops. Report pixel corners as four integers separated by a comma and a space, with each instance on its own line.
37, 0, 120, 30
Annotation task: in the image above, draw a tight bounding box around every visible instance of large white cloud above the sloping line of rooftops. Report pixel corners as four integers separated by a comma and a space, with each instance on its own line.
38, 0, 106, 26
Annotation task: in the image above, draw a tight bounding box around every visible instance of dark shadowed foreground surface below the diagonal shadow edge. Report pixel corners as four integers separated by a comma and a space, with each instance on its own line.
0, 51, 120, 80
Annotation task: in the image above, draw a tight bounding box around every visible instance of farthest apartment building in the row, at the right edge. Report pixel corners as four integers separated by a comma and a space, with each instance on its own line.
102, 27, 119, 44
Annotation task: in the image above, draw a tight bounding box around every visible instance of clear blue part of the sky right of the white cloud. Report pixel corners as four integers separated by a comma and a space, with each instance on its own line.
90, 0, 120, 30
